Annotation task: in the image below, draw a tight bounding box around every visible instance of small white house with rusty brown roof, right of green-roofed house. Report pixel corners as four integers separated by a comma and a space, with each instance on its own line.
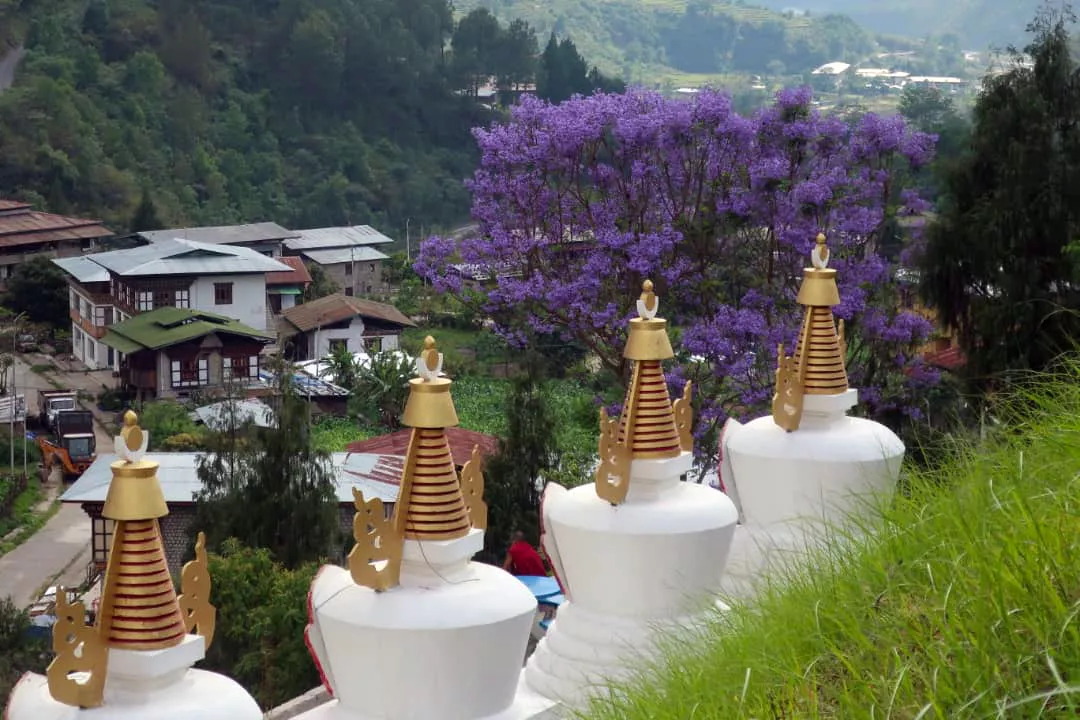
279, 293, 416, 361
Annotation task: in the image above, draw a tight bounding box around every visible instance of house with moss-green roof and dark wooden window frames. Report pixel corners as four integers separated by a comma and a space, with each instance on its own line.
102, 307, 274, 399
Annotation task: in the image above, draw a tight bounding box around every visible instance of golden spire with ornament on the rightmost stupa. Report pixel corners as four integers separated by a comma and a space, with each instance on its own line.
772, 234, 848, 432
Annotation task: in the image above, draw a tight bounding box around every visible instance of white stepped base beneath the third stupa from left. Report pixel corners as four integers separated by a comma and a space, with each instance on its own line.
523, 600, 727, 709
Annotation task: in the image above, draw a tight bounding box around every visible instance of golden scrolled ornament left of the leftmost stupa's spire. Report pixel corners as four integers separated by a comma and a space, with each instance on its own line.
45, 587, 109, 708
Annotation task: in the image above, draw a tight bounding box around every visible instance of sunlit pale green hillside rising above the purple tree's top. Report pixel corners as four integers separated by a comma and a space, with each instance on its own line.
455, 0, 876, 82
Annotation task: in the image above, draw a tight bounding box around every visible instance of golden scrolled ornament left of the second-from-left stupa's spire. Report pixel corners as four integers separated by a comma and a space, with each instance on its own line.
349, 488, 405, 593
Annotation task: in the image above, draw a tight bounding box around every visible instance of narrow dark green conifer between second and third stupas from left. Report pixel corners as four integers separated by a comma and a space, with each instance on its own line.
478, 372, 558, 563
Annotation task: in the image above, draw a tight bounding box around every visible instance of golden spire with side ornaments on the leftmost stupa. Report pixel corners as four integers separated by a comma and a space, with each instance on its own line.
46, 410, 214, 707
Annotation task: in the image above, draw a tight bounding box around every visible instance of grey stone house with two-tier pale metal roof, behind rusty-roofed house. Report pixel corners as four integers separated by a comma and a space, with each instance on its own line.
284, 225, 394, 296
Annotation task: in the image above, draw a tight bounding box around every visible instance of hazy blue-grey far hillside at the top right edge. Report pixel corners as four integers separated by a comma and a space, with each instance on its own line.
756, 0, 1043, 50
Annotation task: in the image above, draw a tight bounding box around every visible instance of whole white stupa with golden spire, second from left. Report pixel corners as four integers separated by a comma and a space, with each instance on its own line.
299, 338, 543, 720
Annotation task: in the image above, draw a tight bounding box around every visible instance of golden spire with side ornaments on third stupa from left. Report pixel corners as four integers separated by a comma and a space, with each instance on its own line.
596, 280, 693, 505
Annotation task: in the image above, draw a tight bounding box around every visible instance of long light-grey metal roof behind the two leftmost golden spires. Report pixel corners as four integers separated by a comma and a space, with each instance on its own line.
60, 452, 401, 504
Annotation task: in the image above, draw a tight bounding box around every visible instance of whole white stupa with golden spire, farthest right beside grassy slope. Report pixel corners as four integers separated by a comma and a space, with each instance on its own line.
724, 235, 904, 561
